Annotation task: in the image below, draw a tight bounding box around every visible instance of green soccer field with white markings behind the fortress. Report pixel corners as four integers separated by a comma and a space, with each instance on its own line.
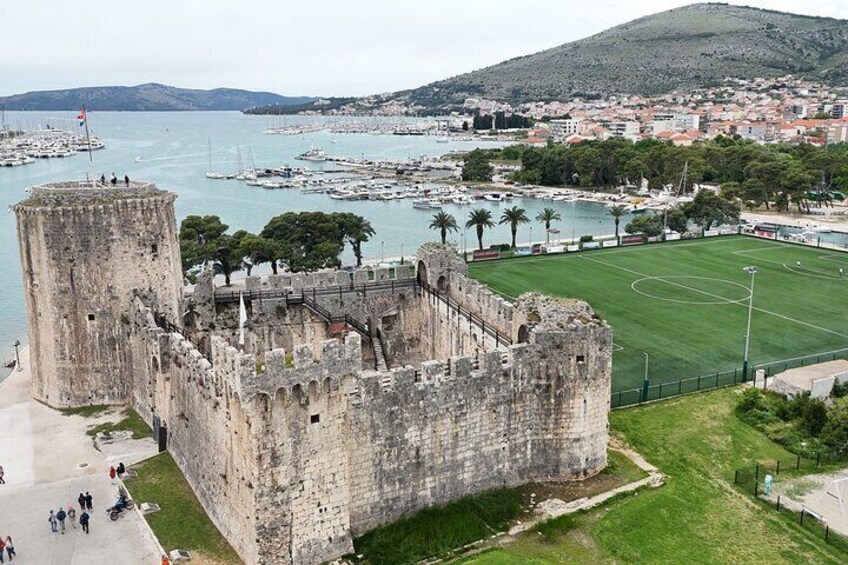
469, 236, 848, 390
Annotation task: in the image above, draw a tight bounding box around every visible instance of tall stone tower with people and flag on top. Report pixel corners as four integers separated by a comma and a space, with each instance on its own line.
15, 182, 183, 406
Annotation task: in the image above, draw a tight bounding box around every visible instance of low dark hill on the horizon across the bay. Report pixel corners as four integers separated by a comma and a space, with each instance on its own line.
0, 83, 314, 111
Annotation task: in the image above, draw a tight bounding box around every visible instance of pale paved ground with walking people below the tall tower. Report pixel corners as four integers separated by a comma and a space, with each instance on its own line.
0, 352, 161, 565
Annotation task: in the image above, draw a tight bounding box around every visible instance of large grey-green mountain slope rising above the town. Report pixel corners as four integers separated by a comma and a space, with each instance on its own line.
397, 4, 848, 106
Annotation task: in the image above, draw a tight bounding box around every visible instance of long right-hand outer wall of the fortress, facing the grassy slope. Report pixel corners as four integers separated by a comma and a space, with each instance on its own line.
349, 304, 611, 534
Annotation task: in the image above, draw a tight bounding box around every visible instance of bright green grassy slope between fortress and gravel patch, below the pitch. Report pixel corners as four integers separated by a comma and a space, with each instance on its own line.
465, 389, 848, 565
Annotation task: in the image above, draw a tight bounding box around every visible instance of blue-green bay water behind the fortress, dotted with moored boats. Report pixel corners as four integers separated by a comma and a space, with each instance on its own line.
0, 112, 624, 373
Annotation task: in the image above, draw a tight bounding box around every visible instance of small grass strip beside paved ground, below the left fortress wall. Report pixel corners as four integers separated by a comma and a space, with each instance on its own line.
127, 453, 241, 564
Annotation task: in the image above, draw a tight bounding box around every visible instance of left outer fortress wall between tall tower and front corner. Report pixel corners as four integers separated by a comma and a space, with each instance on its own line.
127, 299, 260, 563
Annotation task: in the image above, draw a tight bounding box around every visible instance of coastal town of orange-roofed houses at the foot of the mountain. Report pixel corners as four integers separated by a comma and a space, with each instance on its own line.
290, 75, 848, 146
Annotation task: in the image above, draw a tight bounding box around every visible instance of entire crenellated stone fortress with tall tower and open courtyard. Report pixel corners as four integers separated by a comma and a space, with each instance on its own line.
15, 182, 612, 564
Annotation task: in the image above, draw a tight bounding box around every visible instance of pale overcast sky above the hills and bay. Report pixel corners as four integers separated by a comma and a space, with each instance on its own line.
0, 0, 848, 96
